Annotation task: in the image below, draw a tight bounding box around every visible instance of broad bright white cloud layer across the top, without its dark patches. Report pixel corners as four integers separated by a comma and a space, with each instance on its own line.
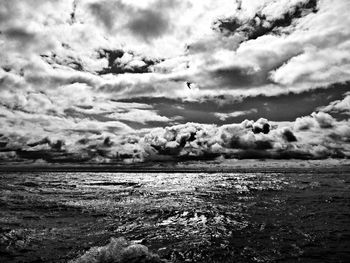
0, 0, 350, 101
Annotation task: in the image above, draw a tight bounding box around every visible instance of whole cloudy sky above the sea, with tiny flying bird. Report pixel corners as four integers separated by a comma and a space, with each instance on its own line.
0, 0, 350, 164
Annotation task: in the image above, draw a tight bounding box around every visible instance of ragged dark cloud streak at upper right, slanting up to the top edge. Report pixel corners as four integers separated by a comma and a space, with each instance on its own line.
213, 0, 318, 39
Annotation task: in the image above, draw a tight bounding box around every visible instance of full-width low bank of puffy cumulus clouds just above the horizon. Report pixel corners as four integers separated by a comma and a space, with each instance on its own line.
0, 112, 350, 163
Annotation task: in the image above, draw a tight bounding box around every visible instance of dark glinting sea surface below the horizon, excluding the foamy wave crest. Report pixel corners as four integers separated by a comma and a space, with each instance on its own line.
0, 171, 350, 262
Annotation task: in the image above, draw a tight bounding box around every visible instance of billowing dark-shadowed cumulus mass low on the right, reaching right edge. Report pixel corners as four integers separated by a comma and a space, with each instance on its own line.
130, 113, 349, 160
